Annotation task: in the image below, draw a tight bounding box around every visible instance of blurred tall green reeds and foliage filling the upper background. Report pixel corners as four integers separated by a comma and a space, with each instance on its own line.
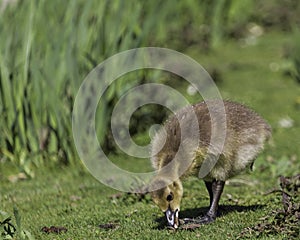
0, 0, 298, 176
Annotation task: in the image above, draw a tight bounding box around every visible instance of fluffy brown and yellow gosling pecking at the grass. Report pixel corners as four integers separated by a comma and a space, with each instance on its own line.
151, 100, 271, 229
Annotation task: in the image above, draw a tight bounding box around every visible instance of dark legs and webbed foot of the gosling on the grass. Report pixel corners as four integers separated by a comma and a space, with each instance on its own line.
184, 180, 225, 224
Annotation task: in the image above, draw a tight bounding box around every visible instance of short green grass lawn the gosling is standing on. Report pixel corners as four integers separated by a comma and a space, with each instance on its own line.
0, 32, 300, 239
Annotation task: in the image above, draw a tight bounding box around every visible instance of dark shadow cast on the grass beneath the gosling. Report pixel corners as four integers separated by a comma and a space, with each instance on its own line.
154, 204, 265, 230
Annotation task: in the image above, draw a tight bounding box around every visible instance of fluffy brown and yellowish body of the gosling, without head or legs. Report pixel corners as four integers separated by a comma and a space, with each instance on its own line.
151, 101, 271, 181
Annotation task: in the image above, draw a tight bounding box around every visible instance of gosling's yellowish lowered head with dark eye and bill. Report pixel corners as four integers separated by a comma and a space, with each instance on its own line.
151, 179, 183, 229
